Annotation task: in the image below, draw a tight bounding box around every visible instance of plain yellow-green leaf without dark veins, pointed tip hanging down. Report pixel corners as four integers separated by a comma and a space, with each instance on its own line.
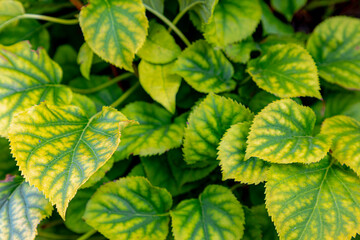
139, 60, 181, 114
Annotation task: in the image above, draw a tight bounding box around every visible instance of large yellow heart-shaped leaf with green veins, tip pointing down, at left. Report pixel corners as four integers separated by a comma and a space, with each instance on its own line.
9, 103, 129, 218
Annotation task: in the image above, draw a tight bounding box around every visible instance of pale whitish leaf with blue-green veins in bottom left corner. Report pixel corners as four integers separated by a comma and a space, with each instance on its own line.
0, 177, 53, 240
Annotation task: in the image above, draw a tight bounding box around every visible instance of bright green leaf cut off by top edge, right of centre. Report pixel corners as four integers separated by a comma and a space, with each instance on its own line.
204, 0, 261, 47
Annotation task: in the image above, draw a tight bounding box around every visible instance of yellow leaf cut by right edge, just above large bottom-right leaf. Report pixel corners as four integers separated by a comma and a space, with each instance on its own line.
321, 116, 360, 176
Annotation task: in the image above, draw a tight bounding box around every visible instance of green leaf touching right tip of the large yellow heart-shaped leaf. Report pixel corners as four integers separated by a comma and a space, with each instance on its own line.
117, 102, 187, 160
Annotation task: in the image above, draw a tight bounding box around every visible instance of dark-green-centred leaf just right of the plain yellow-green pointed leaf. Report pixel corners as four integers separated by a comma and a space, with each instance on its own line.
174, 40, 236, 93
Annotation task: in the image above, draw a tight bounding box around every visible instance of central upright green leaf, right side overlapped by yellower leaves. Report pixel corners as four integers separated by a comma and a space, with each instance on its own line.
183, 94, 253, 164
